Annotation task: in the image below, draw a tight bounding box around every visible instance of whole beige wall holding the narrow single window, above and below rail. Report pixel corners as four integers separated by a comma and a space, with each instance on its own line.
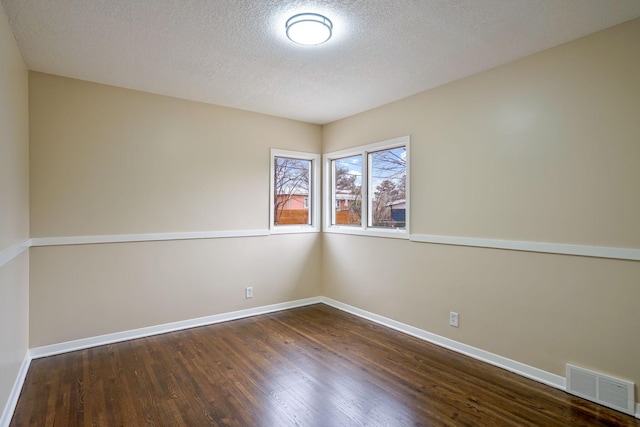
29, 72, 321, 347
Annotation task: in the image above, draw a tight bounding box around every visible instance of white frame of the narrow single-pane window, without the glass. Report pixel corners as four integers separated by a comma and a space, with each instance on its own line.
269, 148, 321, 234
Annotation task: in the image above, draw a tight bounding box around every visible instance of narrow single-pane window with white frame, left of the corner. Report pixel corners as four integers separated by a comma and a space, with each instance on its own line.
270, 149, 320, 233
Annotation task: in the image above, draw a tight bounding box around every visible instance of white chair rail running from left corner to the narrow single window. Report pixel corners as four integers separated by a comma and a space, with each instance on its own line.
31, 230, 269, 246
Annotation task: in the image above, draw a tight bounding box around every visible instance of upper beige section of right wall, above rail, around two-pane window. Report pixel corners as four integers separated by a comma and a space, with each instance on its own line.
323, 20, 640, 248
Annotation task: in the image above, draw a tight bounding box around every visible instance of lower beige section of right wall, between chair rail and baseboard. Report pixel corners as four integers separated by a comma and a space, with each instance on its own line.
323, 234, 640, 394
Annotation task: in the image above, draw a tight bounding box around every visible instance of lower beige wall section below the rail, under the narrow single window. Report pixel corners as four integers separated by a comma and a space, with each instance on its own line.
30, 234, 321, 348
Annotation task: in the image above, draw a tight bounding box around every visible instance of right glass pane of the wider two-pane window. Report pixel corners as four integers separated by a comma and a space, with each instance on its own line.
368, 147, 407, 229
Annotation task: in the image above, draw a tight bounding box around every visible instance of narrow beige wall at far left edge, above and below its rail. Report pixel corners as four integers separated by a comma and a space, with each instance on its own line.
0, 3, 29, 419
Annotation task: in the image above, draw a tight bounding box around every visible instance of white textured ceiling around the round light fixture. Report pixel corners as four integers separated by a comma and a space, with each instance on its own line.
2, 0, 640, 124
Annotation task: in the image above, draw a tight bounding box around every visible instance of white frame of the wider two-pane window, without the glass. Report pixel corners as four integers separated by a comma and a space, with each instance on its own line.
322, 135, 411, 239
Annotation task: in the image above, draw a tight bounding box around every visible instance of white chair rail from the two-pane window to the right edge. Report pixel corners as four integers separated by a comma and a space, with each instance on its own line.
409, 234, 640, 261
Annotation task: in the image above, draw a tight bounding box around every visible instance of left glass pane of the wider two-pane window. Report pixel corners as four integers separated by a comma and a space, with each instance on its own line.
331, 156, 362, 226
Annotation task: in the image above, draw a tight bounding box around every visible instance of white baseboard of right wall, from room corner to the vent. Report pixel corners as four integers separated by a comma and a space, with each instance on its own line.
322, 297, 566, 390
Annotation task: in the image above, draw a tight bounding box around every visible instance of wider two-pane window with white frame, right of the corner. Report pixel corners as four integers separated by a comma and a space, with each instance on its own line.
324, 136, 409, 238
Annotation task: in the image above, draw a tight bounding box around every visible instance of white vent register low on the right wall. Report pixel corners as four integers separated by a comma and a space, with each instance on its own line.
567, 364, 635, 415
